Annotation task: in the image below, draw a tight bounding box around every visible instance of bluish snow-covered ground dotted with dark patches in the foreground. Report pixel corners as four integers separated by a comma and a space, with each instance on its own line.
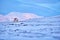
0, 16, 60, 40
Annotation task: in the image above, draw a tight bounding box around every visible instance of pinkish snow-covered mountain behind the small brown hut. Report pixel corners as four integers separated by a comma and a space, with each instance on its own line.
0, 12, 42, 22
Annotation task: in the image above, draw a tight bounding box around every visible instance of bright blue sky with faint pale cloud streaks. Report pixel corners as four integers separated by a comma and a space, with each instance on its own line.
0, 0, 60, 16
